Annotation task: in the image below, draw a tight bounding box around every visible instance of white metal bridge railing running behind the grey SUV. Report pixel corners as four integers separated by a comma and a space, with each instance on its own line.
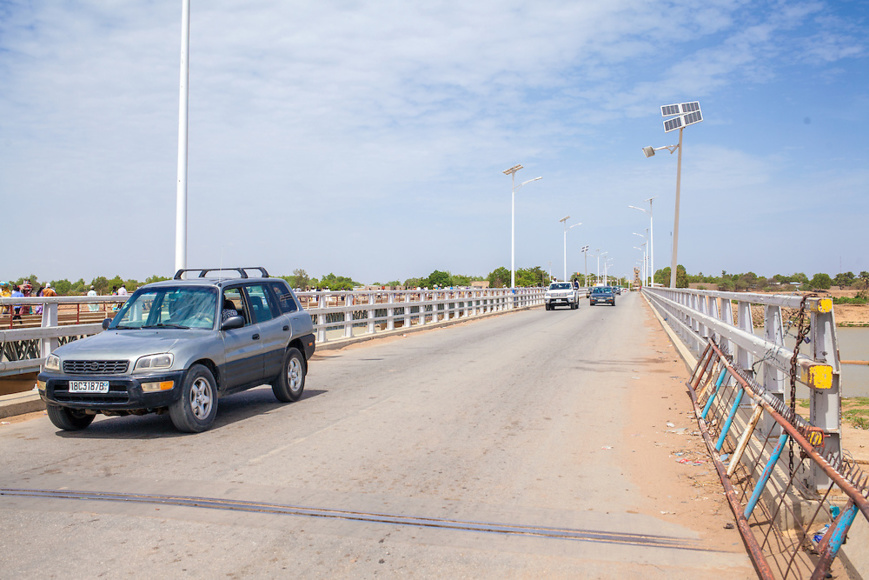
0, 288, 544, 375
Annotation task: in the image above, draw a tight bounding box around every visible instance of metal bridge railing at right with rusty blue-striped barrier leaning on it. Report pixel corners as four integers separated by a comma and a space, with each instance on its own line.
643, 288, 869, 578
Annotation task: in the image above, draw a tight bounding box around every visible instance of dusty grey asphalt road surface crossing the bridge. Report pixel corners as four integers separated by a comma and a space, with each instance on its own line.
0, 295, 747, 578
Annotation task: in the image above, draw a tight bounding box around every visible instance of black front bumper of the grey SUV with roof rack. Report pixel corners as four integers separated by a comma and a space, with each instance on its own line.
36, 370, 185, 411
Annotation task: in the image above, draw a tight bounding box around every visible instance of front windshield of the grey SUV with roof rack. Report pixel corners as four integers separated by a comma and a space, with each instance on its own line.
109, 286, 217, 329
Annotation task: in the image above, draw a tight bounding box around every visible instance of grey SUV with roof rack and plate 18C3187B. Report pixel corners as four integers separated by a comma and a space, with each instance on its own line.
37, 268, 314, 432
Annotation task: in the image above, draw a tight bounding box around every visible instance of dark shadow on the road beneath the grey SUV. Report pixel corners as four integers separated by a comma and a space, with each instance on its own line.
56, 385, 328, 439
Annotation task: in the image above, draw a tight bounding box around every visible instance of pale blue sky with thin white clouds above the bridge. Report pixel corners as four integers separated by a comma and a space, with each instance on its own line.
0, 0, 869, 283
